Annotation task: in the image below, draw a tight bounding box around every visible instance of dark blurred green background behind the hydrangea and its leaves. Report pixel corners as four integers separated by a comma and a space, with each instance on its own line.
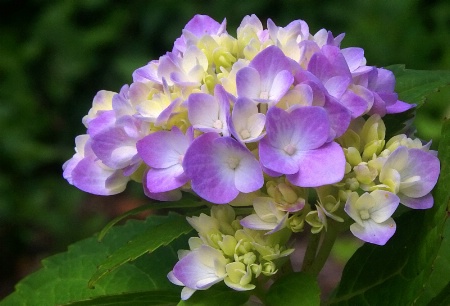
0, 0, 450, 299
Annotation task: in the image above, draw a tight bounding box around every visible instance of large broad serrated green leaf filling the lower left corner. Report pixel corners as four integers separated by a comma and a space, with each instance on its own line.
0, 216, 188, 306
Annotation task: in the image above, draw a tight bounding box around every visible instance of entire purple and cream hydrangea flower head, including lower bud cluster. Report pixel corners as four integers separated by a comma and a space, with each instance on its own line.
63, 15, 440, 298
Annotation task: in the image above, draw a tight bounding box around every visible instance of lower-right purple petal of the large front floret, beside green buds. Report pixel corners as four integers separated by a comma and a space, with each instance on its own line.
287, 142, 345, 187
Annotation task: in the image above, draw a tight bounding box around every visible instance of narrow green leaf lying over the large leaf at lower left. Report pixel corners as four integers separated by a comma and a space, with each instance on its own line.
89, 216, 192, 287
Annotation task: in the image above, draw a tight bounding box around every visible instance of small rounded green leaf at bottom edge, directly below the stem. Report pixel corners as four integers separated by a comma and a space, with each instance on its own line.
265, 272, 320, 306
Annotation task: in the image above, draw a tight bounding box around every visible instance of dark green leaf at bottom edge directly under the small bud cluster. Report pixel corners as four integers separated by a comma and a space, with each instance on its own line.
178, 283, 250, 306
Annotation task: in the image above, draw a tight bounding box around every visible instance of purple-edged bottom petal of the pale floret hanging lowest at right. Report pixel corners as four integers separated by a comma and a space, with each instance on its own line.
350, 218, 396, 245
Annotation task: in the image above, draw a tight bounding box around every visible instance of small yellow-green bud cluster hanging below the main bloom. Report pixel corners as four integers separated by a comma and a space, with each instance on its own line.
168, 205, 294, 299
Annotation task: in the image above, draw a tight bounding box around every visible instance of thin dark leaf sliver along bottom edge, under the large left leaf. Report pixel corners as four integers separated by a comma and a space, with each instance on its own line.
64, 291, 180, 306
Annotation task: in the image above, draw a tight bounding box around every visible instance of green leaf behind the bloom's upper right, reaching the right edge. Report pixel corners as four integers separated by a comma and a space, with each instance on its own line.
386, 65, 450, 107
